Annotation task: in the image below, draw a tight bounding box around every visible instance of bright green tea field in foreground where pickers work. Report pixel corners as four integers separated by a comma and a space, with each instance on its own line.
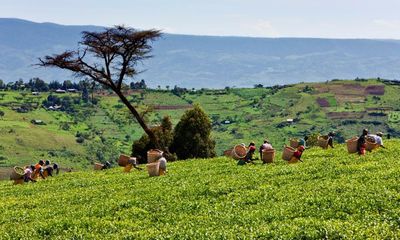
0, 140, 400, 239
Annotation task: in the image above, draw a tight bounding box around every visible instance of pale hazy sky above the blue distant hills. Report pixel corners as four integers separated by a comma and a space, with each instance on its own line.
0, 0, 400, 39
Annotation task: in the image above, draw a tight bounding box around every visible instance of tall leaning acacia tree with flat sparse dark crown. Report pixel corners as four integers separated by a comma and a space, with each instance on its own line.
37, 26, 161, 146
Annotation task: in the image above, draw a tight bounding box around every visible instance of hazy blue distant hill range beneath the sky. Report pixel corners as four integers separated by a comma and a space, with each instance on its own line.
0, 18, 400, 88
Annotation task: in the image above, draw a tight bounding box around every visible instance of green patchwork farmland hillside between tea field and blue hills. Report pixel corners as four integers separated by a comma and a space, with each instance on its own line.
0, 79, 400, 179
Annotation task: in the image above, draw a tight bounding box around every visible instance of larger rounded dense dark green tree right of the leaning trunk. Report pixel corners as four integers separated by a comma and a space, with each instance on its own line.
171, 105, 215, 159
